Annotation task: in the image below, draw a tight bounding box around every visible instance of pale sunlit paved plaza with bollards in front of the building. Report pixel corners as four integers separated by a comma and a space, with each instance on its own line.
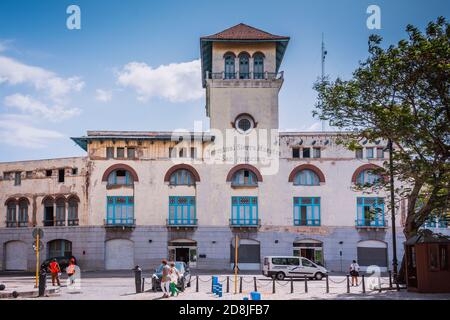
0, 271, 450, 301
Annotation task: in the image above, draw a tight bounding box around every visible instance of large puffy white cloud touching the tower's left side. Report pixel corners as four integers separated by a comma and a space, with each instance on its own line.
117, 60, 204, 102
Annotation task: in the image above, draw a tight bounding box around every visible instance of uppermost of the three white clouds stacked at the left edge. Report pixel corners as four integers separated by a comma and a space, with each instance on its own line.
0, 56, 84, 100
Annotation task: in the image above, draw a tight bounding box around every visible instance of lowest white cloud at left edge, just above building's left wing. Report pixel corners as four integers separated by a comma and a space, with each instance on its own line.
0, 115, 64, 149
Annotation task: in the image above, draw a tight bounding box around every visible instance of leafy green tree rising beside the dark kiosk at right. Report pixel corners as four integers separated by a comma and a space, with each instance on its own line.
314, 17, 450, 238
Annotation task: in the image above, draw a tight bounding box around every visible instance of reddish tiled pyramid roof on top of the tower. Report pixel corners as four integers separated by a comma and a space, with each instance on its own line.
202, 23, 289, 41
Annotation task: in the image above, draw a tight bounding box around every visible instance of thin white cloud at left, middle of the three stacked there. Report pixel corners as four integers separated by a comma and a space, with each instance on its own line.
4, 93, 81, 122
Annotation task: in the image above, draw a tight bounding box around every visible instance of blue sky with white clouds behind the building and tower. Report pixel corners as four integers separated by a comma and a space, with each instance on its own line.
0, 0, 450, 161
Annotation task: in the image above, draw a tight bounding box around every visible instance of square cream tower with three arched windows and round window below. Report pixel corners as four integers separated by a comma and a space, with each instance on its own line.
200, 23, 289, 133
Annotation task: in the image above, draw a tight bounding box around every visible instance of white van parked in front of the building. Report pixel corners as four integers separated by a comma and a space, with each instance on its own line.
262, 256, 328, 280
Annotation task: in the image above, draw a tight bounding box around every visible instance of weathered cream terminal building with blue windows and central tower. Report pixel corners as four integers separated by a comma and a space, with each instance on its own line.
0, 24, 446, 272
